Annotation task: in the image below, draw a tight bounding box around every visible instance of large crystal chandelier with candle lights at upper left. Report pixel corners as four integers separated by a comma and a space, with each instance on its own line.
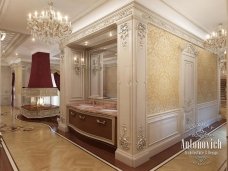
27, 0, 72, 44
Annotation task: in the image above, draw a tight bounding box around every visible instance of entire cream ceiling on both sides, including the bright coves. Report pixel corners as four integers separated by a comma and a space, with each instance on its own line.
0, 0, 228, 63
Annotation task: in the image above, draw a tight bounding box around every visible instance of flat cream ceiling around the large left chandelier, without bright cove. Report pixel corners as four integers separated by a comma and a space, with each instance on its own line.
0, 0, 107, 62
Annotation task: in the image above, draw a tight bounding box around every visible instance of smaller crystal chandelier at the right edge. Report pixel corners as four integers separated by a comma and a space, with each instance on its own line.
204, 24, 227, 54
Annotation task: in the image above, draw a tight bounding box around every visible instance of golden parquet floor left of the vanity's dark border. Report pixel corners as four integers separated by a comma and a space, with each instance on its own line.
0, 107, 116, 171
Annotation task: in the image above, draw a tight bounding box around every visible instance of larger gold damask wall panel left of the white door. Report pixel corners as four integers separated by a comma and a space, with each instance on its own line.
147, 25, 185, 114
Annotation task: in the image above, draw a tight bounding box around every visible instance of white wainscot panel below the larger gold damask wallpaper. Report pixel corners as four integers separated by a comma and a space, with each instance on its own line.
147, 109, 182, 156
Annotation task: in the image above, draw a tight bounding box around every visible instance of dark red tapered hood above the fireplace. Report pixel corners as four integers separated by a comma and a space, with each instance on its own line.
28, 52, 53, 88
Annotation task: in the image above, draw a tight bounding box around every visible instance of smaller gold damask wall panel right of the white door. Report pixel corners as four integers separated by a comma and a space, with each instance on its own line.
197, 48, 218, 104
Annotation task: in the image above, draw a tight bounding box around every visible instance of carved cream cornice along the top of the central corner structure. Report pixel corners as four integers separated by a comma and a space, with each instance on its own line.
64, 2, 203, 47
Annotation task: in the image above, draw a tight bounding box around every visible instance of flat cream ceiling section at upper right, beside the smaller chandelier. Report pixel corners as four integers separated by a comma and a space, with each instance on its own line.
161, 0, 227, 32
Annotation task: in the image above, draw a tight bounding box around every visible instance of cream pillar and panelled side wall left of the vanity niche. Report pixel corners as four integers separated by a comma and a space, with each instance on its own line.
58, 44, 86, 132
